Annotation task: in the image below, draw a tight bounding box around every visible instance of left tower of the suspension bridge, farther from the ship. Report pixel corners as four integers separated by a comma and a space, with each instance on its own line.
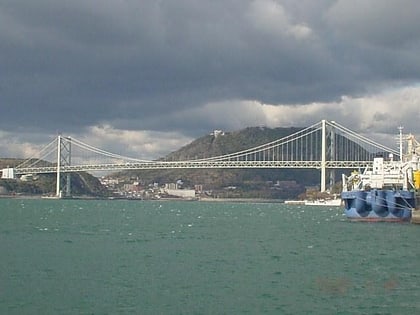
56, 135, 71, 198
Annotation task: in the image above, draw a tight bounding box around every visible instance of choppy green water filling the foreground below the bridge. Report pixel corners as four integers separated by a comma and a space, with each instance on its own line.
0, 199, 420, 314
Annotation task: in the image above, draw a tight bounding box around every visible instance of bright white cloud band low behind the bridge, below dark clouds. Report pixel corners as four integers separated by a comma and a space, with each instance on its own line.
0, 86, 420, 162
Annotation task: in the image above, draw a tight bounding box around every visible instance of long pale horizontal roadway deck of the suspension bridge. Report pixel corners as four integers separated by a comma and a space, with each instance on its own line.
15, 160, 372, 175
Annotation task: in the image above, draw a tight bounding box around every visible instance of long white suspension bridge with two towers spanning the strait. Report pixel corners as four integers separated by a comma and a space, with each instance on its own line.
2, 120, 402, 196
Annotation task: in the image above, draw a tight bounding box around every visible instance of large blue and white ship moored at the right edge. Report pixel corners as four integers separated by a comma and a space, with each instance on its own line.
341, 130, 420, 221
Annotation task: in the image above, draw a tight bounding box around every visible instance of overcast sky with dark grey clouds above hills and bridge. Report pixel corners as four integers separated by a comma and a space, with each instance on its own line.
0, 0, 420, 159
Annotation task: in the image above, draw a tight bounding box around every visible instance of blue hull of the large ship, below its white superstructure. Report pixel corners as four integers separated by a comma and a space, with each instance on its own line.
341, 189, 416, 221
